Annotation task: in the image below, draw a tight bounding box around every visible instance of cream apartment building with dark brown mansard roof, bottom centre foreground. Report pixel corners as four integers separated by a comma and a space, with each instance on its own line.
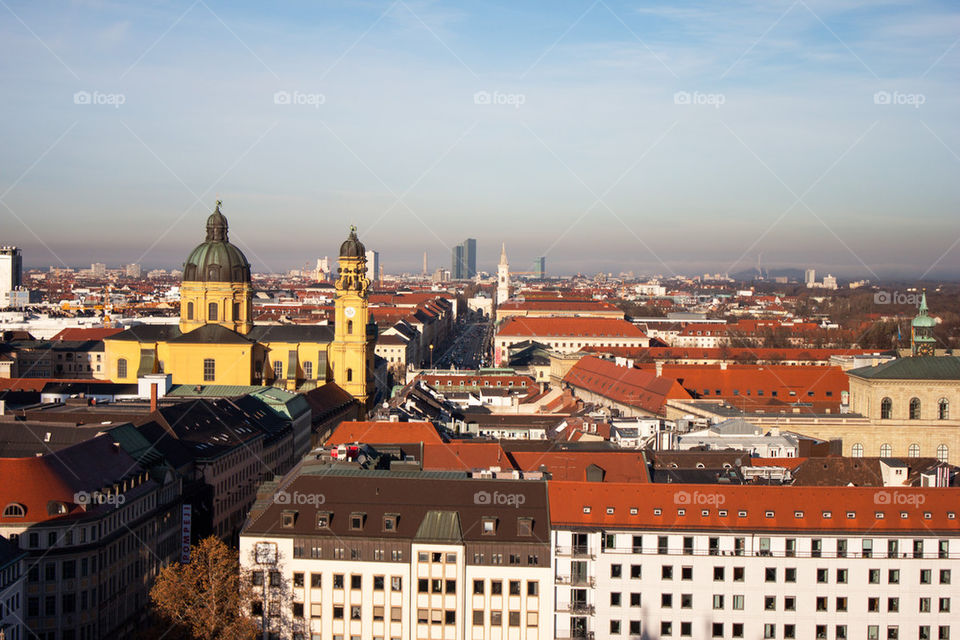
240, 462, 553, 640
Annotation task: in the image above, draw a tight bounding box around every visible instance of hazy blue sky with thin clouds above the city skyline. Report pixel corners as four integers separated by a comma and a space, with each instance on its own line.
0, 0, 960, 281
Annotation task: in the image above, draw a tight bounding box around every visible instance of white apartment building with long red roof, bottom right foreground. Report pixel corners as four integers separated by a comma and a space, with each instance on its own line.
549, 482, 960, 640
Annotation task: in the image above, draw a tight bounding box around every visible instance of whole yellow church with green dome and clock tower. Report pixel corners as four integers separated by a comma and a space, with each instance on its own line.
104, 201, 377, 406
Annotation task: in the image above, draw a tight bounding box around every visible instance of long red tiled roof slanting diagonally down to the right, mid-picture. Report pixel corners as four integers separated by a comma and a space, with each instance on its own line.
563, 356, 690, 415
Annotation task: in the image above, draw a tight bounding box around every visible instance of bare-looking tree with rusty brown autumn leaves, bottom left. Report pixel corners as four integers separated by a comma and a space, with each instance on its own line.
150, 536, 258, 640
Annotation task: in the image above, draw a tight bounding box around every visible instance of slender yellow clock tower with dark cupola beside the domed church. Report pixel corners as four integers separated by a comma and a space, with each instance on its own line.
330, 227, 377, 409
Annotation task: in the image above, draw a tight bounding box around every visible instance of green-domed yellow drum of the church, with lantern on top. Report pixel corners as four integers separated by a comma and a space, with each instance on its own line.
180, 200, 253, 335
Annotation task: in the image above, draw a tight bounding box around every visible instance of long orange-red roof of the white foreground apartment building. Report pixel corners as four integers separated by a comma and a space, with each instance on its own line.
547, 481, 960, 534
